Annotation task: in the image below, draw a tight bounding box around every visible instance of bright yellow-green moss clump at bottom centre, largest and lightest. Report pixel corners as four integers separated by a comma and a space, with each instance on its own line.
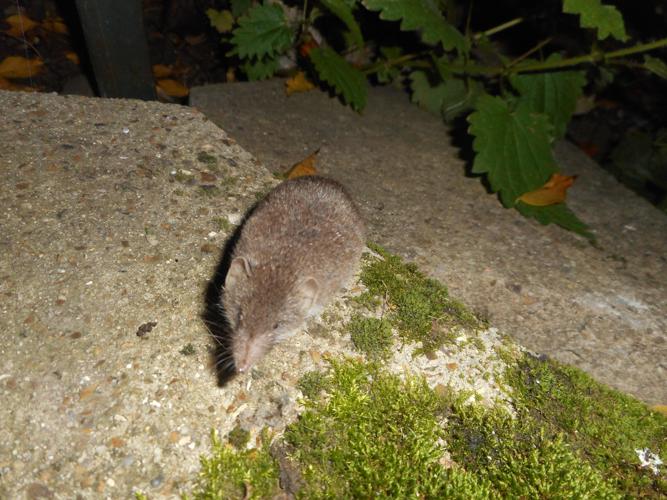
285, 361, 489, 498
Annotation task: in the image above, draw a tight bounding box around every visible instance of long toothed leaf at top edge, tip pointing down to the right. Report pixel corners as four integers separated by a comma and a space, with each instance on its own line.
362, 0, 468, 52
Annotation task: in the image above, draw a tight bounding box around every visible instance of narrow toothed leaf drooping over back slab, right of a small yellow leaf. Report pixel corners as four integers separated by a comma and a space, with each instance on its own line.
308, 47, 367, 111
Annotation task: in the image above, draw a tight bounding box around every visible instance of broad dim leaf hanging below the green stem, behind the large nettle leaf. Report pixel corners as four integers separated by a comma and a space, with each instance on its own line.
510, 54, 586, 138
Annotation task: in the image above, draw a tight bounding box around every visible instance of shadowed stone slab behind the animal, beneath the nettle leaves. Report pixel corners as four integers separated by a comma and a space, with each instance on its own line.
191, 81, 667, 403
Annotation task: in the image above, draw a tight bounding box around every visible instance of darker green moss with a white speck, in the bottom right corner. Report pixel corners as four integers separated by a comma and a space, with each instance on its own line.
507, 355, 667, 498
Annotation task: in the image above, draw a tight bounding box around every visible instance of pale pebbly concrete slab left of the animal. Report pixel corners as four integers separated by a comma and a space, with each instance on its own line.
0, 92, 284, 498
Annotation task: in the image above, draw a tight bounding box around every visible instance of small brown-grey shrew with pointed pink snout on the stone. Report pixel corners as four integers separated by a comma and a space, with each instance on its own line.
223, 176, 365, 372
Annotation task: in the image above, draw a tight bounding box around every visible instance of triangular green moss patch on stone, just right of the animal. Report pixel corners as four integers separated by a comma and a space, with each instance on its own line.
357, 244, 483, 352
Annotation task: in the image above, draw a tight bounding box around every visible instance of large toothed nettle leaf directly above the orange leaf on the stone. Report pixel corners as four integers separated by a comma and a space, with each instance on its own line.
468, 94, 557, 207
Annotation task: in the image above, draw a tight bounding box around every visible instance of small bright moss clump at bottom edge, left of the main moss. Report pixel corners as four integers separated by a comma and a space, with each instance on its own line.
192, 433, 280, 500
